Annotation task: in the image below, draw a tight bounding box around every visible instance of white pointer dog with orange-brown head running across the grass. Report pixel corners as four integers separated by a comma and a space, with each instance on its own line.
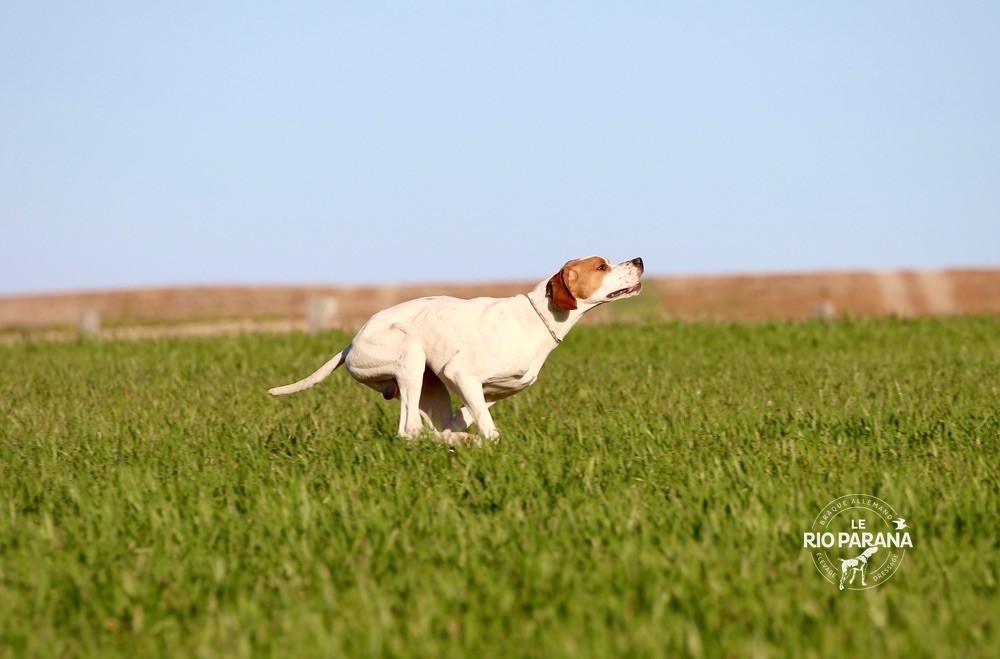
268, 256, 644, 444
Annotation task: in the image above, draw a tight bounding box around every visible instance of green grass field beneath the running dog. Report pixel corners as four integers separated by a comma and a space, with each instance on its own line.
0, 317, 1000, 657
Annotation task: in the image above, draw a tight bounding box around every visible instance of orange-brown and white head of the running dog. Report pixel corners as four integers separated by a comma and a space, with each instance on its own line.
545, 256, 644, 311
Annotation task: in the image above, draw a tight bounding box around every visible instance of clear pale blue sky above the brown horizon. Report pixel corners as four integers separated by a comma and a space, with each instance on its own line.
0, 0, 1000, 294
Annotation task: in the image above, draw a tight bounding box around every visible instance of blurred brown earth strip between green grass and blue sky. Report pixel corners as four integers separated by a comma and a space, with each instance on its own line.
0, 269, 1000, 336
